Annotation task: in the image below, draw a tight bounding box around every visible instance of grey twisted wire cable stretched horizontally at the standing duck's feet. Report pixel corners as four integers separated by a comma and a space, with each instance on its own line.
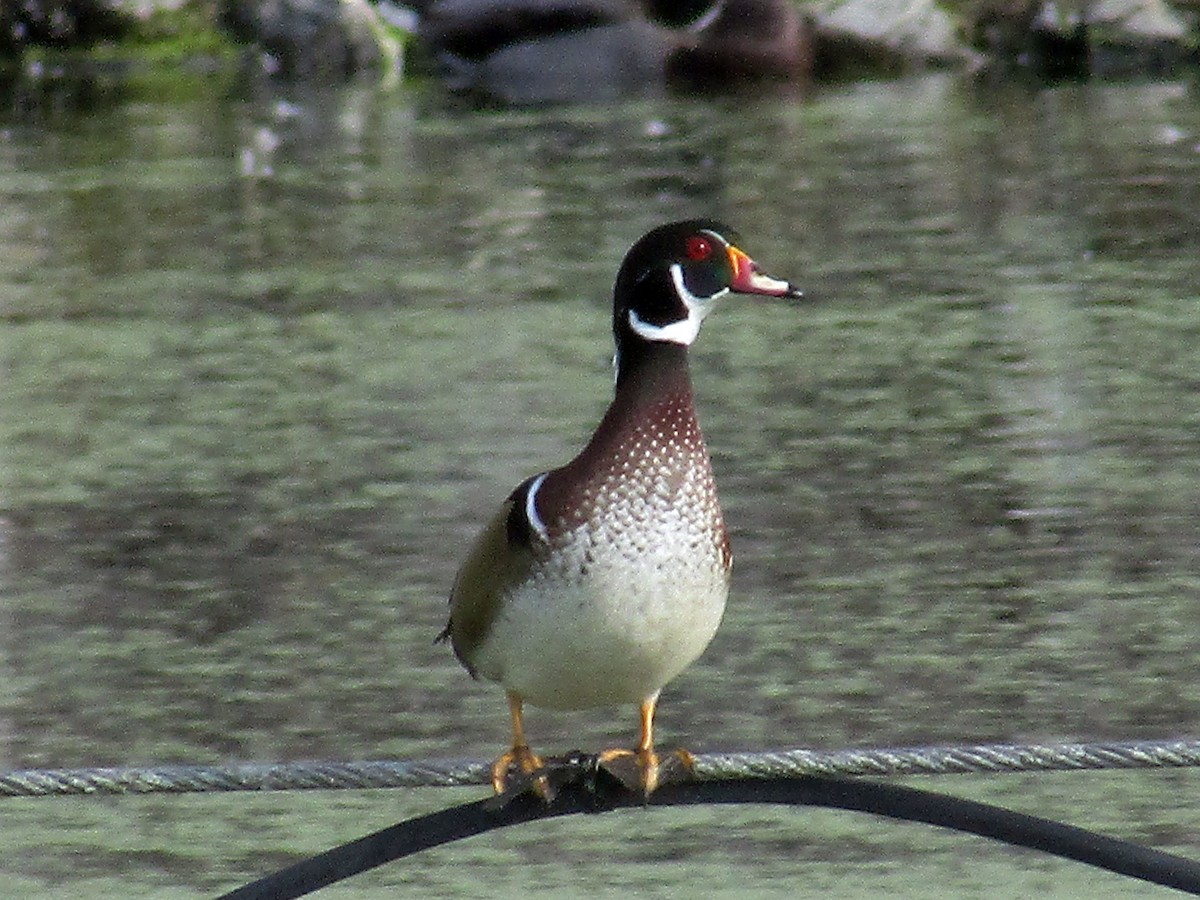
0, 739, 1200, 797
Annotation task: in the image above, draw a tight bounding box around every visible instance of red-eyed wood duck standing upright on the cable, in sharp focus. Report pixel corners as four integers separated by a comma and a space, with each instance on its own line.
438, 220, 800, 799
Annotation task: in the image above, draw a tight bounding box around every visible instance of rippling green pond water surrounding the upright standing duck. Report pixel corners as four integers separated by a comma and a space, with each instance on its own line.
0, 78, 1200, 898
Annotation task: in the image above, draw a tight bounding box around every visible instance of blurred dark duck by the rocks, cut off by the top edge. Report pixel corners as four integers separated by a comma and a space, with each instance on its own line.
419, 0, 814, 104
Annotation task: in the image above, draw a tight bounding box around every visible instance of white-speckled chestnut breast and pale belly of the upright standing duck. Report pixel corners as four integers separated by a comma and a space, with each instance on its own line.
475, 386, 731, 709
